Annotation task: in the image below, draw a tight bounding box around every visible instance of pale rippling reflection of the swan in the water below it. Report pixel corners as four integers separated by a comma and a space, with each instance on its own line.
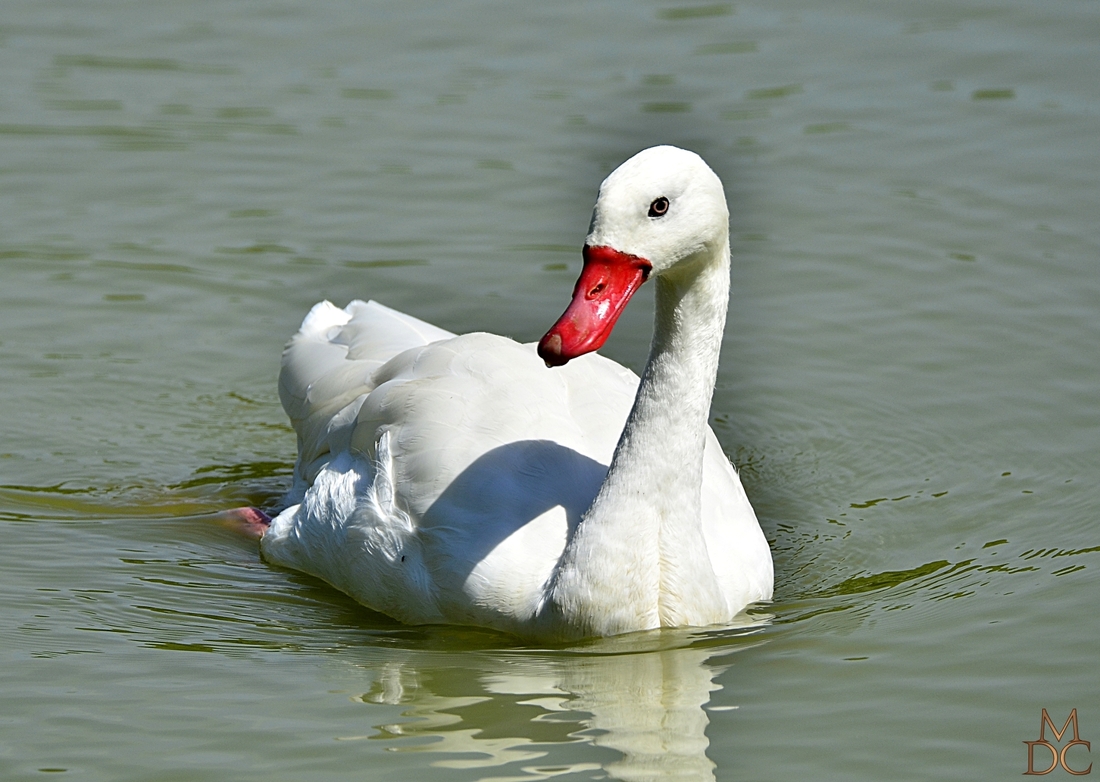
345, 618, 763, 782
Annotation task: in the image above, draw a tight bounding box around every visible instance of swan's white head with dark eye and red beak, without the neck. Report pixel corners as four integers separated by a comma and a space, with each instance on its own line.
539, 146, 729, 366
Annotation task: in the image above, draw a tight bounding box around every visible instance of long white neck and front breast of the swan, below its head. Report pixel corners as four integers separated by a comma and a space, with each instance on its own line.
552, 238, 729, 635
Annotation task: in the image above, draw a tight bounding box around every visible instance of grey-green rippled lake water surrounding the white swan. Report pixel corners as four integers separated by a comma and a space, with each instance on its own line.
0, 0, 1100, 782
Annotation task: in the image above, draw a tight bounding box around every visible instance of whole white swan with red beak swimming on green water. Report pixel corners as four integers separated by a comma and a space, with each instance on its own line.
260, 146, 772, 639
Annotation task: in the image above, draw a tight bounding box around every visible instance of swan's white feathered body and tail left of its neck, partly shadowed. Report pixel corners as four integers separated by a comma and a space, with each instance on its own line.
264, 302, 638, 629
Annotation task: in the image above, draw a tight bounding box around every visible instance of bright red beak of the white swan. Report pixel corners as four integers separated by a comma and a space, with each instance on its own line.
539, 244, 652, 366
